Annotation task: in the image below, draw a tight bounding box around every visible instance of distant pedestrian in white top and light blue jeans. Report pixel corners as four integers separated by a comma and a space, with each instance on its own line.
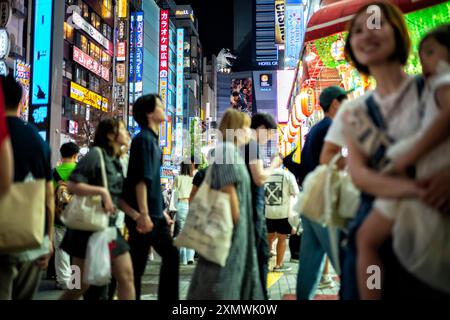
173, 162, 195, 265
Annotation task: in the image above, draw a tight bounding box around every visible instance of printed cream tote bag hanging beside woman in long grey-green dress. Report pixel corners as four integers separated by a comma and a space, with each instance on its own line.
174, 167, 233, 267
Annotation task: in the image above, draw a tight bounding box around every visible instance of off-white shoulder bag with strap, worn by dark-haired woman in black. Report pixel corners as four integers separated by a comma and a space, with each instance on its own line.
61, 147, 109, 231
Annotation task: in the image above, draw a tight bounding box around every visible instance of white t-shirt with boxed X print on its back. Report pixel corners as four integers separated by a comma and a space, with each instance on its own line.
264, 168, 300, 219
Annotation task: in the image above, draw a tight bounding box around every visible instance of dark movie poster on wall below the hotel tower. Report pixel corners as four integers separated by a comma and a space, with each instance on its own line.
230, 78, 253, 116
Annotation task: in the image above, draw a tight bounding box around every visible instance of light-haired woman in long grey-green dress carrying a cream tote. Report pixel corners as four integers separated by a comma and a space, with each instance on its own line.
188, 109, 264, 300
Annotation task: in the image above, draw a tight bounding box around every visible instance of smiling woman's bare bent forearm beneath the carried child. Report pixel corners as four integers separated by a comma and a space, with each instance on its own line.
347, 138, 420, 198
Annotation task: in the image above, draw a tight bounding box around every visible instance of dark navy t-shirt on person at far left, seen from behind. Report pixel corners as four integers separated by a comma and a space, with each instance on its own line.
7, 117, 52, 182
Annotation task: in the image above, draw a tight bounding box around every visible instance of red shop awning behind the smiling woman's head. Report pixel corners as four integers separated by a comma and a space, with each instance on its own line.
305, 0, 446, 42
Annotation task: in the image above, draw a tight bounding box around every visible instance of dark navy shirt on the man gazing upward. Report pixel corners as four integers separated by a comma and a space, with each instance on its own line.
123, 128, 164, 218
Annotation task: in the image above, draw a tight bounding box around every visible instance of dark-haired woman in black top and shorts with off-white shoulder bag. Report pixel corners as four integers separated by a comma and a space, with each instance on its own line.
60, 119, 135, 300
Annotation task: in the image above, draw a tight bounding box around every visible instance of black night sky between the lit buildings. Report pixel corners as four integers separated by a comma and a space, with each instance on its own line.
175, 0, 233, 57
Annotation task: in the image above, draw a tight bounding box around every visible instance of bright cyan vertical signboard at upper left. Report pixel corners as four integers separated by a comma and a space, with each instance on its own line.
29, 0, 53, 136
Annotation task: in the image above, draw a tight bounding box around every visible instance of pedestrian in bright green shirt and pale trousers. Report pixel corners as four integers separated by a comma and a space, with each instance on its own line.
53, 142, 80, 290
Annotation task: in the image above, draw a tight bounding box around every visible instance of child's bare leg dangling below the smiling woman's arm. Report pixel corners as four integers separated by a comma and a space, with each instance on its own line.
357, 209, 393, 300
